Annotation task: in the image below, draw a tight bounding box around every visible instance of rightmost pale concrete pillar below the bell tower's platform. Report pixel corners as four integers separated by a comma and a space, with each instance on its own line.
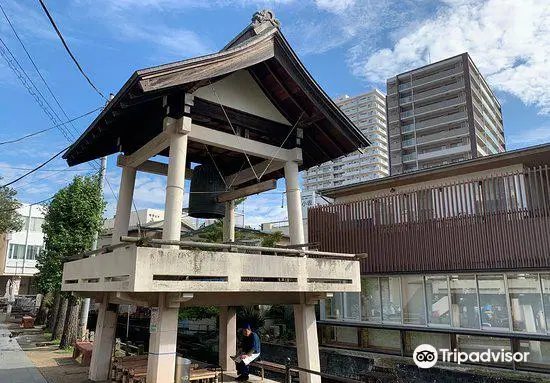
294, 303, 321, 383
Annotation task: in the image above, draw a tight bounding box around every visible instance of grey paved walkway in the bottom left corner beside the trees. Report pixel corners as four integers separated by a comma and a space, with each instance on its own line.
0, 323, 47, 383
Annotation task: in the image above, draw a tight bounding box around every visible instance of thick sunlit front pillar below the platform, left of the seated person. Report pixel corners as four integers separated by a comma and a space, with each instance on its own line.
147, 293, 179, 383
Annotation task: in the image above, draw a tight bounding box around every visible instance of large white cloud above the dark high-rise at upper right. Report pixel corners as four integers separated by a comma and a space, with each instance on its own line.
349, 0, 550, 114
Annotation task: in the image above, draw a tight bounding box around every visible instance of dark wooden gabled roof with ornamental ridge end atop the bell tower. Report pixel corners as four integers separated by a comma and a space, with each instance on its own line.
63, 11, 370, 183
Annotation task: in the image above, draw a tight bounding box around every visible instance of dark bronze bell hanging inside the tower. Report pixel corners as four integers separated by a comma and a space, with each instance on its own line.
189, 164, 225, 218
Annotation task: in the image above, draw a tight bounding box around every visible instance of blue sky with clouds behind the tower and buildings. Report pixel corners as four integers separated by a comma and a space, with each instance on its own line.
0, 0, 550, 225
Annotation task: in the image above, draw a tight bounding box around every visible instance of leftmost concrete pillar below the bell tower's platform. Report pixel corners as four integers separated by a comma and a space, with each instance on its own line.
88, 293, 117, 382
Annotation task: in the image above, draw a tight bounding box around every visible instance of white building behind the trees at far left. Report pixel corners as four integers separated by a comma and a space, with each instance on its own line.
2, 204, 45, 276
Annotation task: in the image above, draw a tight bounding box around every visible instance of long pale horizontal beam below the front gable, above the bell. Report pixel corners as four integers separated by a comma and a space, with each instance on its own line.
189, 124, 302, 162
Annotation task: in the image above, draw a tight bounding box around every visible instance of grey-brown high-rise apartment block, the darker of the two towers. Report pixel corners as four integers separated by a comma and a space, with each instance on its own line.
386, 53, 505, 175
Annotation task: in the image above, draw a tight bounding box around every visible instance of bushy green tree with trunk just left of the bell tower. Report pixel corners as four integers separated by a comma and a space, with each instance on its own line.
36, 176, 105, 348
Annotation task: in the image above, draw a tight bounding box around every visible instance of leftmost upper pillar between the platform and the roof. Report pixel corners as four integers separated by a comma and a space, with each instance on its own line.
111, 166, 136, 245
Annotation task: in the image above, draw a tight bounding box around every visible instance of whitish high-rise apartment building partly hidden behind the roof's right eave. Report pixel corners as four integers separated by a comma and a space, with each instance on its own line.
303, 89, 389, 194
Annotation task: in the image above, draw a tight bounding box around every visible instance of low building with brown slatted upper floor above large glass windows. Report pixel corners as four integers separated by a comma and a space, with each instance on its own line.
308, 144, 550, 372
